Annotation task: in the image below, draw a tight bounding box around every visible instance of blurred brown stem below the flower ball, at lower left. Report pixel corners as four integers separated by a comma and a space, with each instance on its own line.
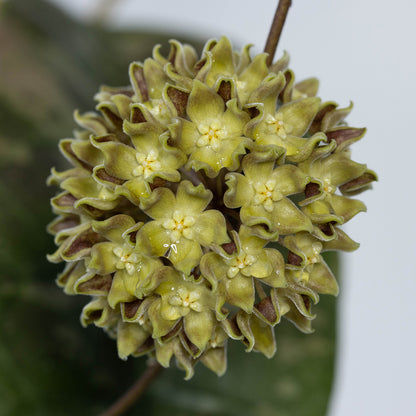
99, 362, 163, 416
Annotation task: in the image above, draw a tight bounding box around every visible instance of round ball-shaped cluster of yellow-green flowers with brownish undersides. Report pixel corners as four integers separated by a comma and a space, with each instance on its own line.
49, 38, 376, 378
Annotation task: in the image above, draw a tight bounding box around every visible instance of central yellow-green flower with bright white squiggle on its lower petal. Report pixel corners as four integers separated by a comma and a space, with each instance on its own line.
138, 181, 230, 273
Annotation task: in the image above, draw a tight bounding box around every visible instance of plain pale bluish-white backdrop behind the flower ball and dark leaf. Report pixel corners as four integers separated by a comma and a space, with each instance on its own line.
48, 0, 416, 416
